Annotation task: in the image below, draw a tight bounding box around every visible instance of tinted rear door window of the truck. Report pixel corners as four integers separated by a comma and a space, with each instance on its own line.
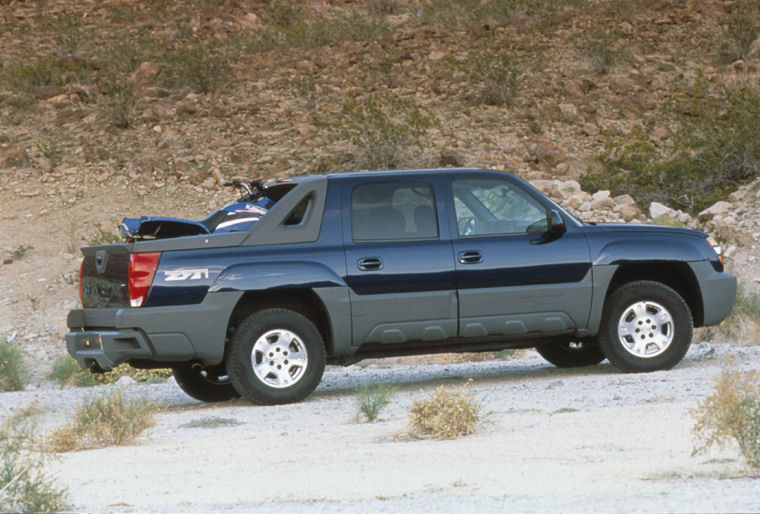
351, 182, 438, 241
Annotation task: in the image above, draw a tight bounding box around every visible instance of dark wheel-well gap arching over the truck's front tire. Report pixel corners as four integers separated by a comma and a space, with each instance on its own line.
604, 262, 704, 327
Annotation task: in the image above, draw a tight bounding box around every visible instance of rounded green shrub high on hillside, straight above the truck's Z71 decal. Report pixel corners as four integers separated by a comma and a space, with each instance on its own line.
162, 43, 232, 93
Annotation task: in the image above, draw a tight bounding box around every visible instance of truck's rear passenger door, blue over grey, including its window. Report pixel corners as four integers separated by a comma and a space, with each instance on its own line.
343, 176, 457, 345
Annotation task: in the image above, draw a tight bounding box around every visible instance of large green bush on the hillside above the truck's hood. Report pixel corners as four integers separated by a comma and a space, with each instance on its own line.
581, 85, 760, 214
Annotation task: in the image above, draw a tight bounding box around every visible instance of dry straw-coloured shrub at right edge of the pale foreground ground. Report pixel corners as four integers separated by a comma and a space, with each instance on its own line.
692, 364, 760, 468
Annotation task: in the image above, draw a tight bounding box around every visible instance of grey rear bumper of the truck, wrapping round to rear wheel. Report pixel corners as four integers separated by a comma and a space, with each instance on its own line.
66, 292, 242, 371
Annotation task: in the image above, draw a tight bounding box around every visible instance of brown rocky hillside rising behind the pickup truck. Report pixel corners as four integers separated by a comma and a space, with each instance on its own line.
0, 0, 760, 376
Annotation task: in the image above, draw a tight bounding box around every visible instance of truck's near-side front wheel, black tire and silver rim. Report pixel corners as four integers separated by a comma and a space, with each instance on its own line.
599, 280, 694, 372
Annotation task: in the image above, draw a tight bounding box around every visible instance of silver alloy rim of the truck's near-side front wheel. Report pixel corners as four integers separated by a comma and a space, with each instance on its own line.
618, 301, 674, 359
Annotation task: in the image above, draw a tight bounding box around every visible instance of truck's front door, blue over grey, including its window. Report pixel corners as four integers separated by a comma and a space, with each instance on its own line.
450, 175, 592, 337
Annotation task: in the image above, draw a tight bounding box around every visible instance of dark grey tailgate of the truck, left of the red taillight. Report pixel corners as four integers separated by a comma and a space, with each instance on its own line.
81, 243, 131, 308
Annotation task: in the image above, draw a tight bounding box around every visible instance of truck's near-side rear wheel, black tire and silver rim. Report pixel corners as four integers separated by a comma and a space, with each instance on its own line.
227, 309, 326, 405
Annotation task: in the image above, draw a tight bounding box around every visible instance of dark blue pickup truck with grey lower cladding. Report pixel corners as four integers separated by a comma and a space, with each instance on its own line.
66, 169, 736, 404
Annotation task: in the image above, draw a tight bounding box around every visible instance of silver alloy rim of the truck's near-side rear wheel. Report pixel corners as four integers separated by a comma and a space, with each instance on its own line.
251, 329, 309, 389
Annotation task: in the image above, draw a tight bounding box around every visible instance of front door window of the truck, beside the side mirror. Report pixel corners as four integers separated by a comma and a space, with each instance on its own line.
452, 179, 548, 237
